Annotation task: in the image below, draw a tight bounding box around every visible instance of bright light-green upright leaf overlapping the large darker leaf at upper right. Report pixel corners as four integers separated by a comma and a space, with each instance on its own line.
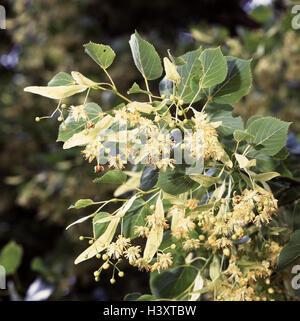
200, 47, 227, 88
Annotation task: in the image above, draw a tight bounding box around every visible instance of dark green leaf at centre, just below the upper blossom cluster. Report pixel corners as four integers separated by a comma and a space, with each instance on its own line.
156, 166, 197, 195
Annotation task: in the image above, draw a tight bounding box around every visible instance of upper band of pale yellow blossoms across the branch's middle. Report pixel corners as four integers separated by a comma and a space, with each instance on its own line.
75, 100, 230, 171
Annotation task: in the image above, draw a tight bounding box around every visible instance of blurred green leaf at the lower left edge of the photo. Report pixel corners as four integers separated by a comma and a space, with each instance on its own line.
0, 241, 23, 275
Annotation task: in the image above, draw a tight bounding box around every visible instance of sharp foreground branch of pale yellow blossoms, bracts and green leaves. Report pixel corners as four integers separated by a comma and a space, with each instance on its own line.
27, 33, 289, 301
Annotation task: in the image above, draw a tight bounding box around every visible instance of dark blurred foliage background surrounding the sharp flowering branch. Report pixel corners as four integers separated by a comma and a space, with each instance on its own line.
0, 0, 300, 300
